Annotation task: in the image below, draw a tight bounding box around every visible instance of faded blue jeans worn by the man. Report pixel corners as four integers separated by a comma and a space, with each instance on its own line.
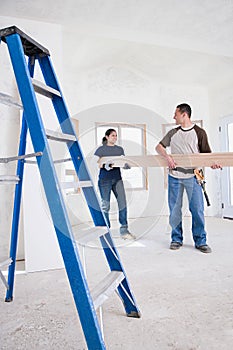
168, 175, 206, 247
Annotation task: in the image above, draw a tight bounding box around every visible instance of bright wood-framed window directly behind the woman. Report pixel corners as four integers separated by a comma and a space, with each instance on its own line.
96, 123, 147, 190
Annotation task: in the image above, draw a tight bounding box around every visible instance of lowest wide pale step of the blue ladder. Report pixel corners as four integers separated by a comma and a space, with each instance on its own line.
91, 271, 125, 309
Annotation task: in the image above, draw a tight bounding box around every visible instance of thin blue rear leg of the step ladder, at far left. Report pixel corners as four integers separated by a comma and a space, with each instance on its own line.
5, 59, 35, 302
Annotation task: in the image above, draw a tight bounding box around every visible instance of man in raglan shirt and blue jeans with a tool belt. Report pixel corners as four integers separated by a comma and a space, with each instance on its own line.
155, 103, 221, 253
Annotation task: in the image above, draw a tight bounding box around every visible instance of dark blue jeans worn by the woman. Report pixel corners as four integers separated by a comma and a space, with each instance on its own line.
98, 179, 128, 235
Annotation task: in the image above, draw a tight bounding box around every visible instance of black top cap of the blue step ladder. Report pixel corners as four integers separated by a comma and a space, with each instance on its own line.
0, 26, 50, 56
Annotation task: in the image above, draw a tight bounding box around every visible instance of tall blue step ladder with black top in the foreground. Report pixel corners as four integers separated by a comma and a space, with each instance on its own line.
0, 26, 140, 350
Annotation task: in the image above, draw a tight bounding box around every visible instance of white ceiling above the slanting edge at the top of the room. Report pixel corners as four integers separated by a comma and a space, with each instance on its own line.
0, 0, 233, 57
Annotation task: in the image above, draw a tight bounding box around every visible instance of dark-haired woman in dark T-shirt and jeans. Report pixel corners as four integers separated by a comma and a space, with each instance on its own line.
95, 129, 136, 239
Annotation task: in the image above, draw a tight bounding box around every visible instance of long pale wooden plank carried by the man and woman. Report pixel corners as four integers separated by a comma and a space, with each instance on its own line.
99, 152, 233, 168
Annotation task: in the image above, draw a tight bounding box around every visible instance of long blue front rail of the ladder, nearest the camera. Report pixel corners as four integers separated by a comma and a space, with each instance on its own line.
6, 34, 105, 350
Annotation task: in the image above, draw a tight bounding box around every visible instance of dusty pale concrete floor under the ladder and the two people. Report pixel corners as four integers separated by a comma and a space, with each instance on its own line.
0, 217, 233, 350
